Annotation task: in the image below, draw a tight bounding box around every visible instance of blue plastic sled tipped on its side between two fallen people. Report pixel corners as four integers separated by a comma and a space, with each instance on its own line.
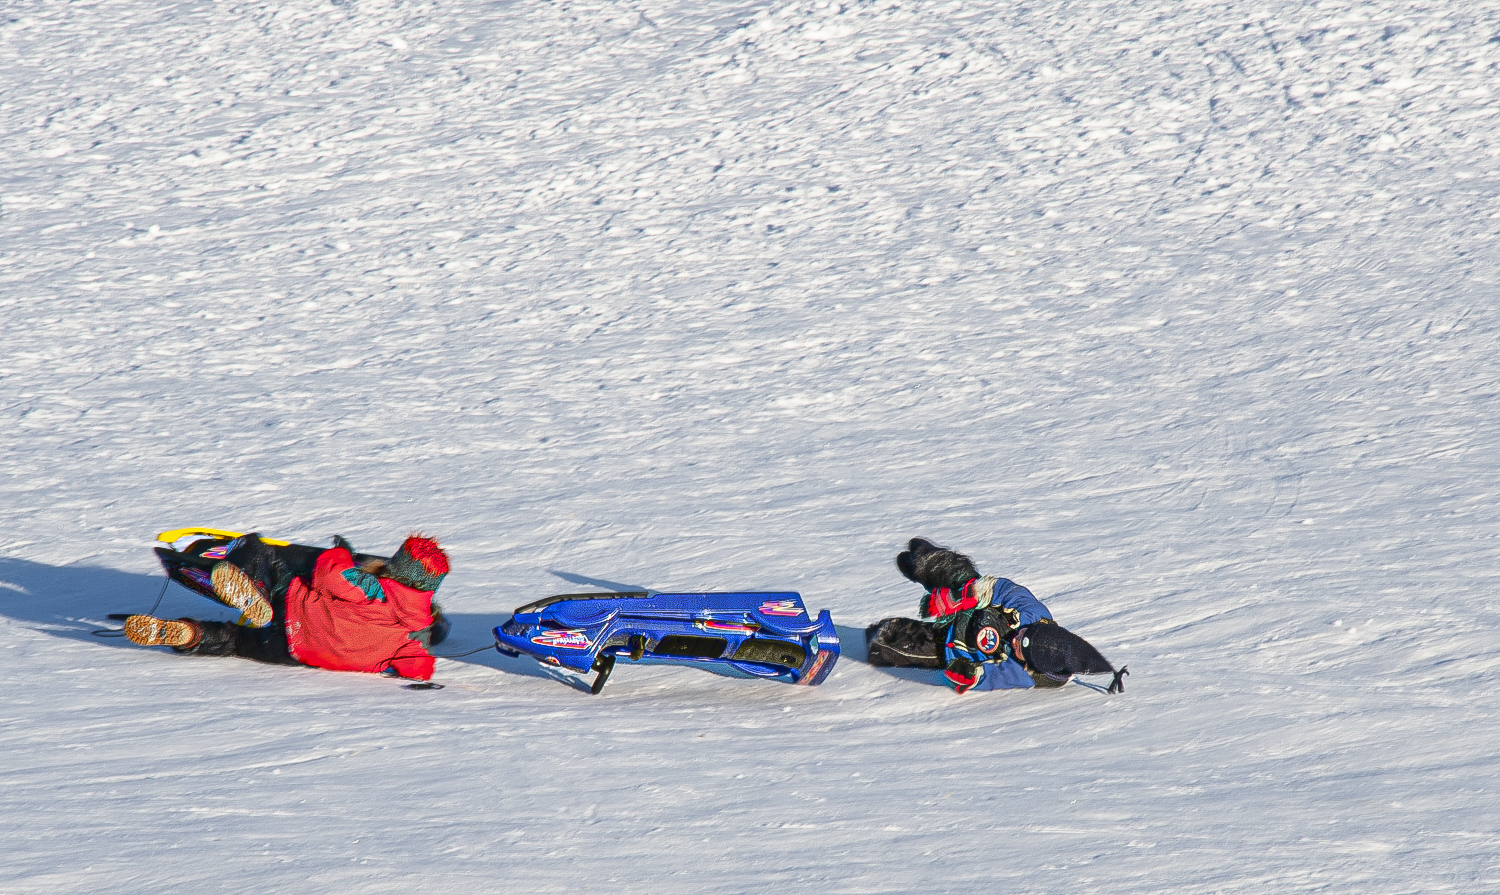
495, 591, 839, 693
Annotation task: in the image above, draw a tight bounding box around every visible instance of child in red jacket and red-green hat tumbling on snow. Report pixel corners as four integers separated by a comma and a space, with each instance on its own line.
125, 534, 449, 681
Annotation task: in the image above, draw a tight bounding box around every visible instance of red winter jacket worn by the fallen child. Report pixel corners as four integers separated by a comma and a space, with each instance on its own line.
287, 547, 434, 681
